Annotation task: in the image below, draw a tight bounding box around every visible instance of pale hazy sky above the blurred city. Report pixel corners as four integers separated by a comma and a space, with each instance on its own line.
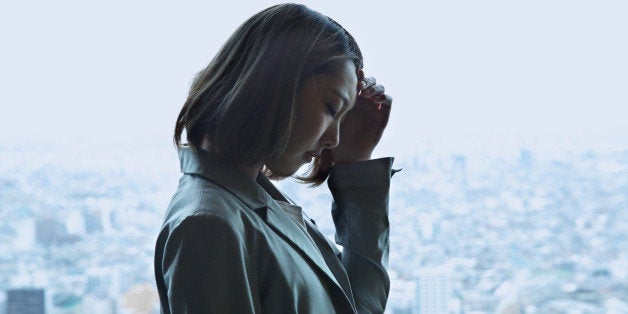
0, 0, 628, 149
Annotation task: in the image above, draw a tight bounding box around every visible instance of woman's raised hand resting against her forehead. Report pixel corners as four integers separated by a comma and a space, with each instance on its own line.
332, 70, 392, 163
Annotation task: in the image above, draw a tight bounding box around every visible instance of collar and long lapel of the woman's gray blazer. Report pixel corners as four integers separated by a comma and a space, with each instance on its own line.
179, 147, 351, 303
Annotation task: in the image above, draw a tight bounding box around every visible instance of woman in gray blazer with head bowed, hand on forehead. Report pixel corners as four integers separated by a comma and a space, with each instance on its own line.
155, 4, 392, 313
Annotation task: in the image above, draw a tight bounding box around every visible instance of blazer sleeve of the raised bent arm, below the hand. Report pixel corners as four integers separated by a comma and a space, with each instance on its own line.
328, 158, 394, 313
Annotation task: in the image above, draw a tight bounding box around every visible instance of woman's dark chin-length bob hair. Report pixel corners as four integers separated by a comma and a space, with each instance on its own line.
174, 4, 363, 185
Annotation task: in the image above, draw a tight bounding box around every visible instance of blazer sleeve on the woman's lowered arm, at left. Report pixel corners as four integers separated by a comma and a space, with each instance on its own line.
160, 215, 259, 313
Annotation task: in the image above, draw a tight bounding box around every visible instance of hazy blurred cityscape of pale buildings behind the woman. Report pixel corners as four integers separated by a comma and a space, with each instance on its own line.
0, 142, 628, 314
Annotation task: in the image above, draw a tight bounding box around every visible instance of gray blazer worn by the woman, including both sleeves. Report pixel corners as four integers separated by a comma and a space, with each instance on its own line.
155, 148, 393, 314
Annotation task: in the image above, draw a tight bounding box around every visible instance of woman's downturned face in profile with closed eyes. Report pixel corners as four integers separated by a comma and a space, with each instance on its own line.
266, 61, 358, 177
